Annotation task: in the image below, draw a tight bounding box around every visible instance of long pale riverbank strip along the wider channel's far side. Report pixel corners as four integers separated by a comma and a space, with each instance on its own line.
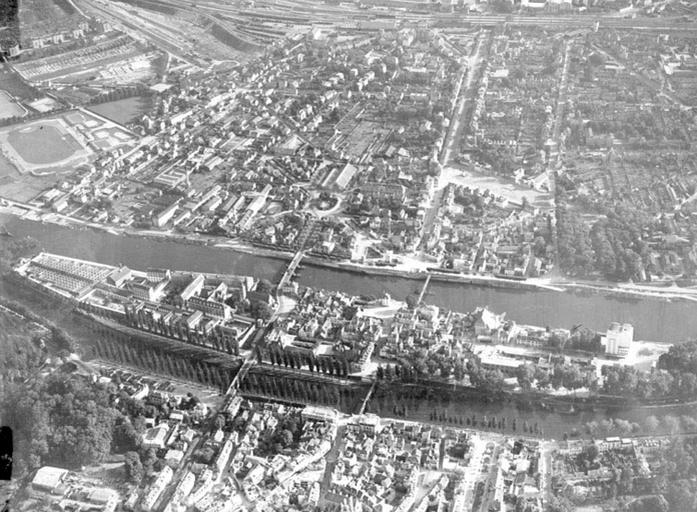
0, 200, 697, 302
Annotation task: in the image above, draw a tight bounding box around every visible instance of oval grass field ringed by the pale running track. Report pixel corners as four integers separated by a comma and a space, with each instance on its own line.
7, 121, 82, 164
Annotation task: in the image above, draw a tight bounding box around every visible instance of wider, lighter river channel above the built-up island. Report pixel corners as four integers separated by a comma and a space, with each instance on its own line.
0, 214, 697, 342
